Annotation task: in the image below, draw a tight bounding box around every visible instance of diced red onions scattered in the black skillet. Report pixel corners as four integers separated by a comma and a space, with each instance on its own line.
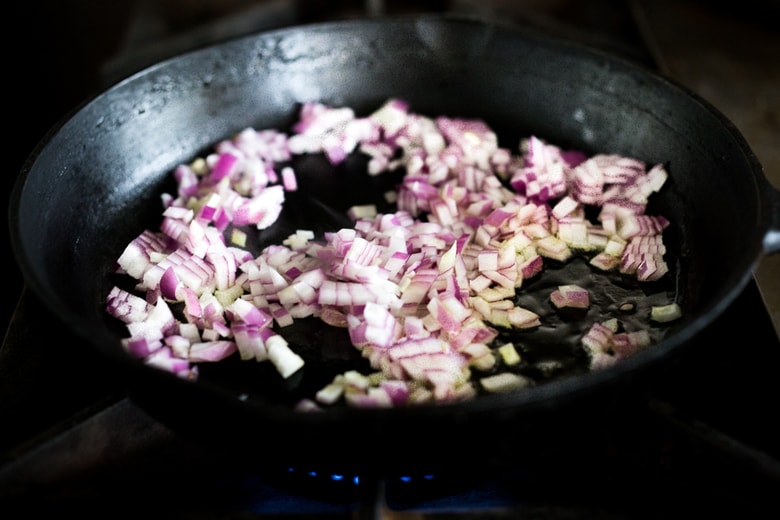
106, 99, 680, 410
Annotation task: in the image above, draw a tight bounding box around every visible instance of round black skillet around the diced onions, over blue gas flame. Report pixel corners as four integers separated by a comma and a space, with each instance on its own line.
9, 15, 780, 474
